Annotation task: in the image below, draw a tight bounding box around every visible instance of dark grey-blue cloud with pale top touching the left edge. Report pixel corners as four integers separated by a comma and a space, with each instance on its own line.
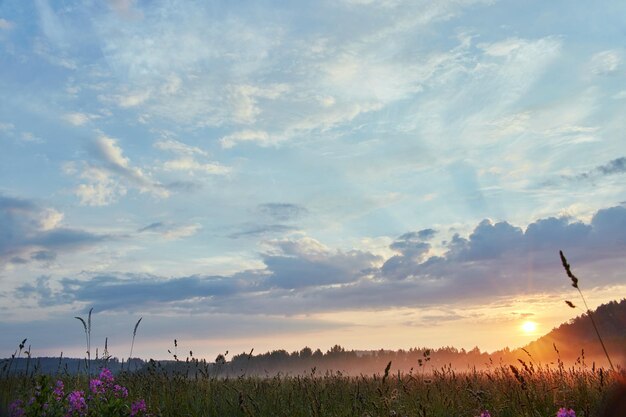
0, 195, 110, 263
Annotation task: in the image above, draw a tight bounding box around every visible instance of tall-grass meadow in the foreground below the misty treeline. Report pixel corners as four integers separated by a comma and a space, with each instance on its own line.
0, 361, 619, 417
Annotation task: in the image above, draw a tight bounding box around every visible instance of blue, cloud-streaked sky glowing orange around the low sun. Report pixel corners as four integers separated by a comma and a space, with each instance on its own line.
0, 0, 626, 359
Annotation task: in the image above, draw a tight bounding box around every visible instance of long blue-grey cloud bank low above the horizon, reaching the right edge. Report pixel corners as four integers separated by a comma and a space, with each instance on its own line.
18, 202, 626, 315
